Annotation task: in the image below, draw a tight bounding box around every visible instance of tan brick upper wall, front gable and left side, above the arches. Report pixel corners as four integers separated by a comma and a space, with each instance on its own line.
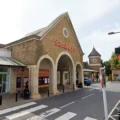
6, 16, 83, 65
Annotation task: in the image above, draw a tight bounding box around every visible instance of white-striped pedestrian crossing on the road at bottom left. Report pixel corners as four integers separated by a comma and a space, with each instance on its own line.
0, 102, 94, 120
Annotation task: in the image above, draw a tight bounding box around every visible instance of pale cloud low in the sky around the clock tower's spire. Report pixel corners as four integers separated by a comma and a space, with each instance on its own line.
81, 23, 120, 61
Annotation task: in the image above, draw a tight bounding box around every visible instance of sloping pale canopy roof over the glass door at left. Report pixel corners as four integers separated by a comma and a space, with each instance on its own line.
0, 57, 25, 67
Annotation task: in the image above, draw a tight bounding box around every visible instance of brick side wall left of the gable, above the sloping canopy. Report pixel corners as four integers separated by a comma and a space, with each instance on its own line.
7, 39, 39, 65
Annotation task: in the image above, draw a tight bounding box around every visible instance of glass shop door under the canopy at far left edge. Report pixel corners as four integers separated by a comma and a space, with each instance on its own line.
0, 74, 9, 93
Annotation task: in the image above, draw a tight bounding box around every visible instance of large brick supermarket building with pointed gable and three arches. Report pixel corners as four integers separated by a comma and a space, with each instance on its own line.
0, 13, 84, 98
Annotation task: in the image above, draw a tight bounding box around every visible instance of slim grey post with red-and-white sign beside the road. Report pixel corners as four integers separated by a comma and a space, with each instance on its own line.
100, 67, 108, 120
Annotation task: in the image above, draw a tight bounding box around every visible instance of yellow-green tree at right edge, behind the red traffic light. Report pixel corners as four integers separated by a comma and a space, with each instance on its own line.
110, 53, 120, 69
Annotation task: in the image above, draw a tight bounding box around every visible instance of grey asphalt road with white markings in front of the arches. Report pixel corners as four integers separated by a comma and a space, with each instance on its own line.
0, 82, 120, 120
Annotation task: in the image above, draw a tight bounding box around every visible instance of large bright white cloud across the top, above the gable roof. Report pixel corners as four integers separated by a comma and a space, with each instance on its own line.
0, 0, 120, 43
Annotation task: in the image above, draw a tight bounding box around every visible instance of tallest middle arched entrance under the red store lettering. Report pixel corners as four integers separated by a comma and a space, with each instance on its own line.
56, 52, 75, 91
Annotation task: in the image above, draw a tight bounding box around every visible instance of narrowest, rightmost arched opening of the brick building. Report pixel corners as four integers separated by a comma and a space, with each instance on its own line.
75, 62, 84, 86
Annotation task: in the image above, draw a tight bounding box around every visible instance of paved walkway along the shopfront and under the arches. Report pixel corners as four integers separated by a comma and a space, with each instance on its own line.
0, 86, 74, 110
